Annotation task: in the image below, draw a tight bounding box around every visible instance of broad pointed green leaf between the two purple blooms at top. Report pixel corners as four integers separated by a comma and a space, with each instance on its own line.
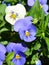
28, 0, 40, 19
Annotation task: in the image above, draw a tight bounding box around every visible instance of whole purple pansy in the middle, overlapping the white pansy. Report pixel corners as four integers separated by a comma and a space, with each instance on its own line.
14, 16, 37, 42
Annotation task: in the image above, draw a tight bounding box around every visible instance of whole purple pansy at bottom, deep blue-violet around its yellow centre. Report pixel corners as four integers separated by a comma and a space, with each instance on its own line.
6, 43, 27, 65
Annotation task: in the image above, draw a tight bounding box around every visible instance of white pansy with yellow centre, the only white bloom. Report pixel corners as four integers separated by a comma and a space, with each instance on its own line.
5, 4, 26, 25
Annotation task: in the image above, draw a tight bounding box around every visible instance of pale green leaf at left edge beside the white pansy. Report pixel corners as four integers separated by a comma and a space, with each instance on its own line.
0, 4, 6, 27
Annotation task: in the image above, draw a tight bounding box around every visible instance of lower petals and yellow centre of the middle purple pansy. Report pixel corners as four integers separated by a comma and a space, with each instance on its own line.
19, 25, 37, 42
